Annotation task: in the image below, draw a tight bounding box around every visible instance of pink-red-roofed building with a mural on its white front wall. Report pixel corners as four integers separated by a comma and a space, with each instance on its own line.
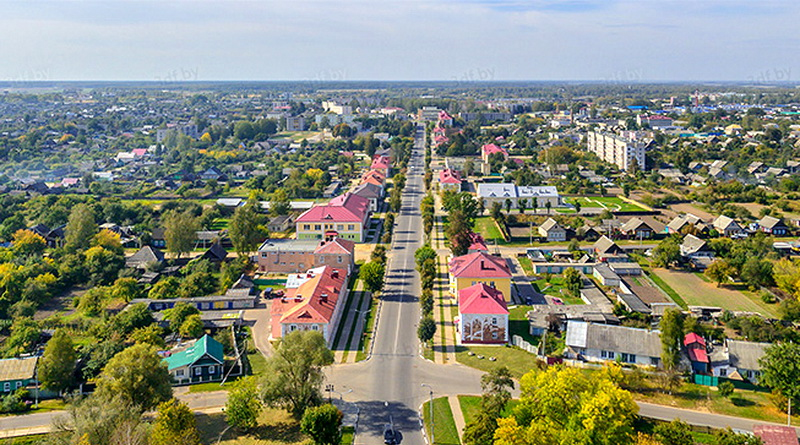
457, 283, 508, 344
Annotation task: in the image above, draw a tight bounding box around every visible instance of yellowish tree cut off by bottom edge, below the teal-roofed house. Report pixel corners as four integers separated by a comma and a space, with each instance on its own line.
150, 399, 200, 445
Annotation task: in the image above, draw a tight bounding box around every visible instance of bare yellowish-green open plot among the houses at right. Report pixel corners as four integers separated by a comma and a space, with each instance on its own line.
653, 269, 775, 316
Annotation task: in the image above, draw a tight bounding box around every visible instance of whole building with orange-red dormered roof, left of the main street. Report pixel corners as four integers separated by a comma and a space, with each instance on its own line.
270, 266, 347, 345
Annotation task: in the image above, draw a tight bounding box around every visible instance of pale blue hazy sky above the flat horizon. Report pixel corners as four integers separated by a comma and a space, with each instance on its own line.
0, 0, 800, 83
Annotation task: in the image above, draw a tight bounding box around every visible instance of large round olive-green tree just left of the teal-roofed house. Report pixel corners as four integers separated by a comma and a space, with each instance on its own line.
97, 343, 172, 411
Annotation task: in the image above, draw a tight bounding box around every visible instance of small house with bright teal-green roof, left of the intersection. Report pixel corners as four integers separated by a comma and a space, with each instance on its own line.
164, 334, 225, 385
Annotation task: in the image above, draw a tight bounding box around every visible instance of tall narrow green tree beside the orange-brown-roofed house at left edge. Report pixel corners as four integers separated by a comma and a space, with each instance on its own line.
38, 328, 77, 392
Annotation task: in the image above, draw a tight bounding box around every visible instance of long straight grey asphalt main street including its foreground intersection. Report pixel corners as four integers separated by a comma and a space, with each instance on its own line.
327, 123, 482, 445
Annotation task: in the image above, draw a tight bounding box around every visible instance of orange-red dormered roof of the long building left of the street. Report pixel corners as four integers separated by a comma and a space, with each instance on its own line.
270, 266, 347, 326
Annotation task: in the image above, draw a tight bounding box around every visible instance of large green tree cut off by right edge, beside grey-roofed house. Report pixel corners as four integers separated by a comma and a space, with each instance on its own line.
758, 343, 800, 407
